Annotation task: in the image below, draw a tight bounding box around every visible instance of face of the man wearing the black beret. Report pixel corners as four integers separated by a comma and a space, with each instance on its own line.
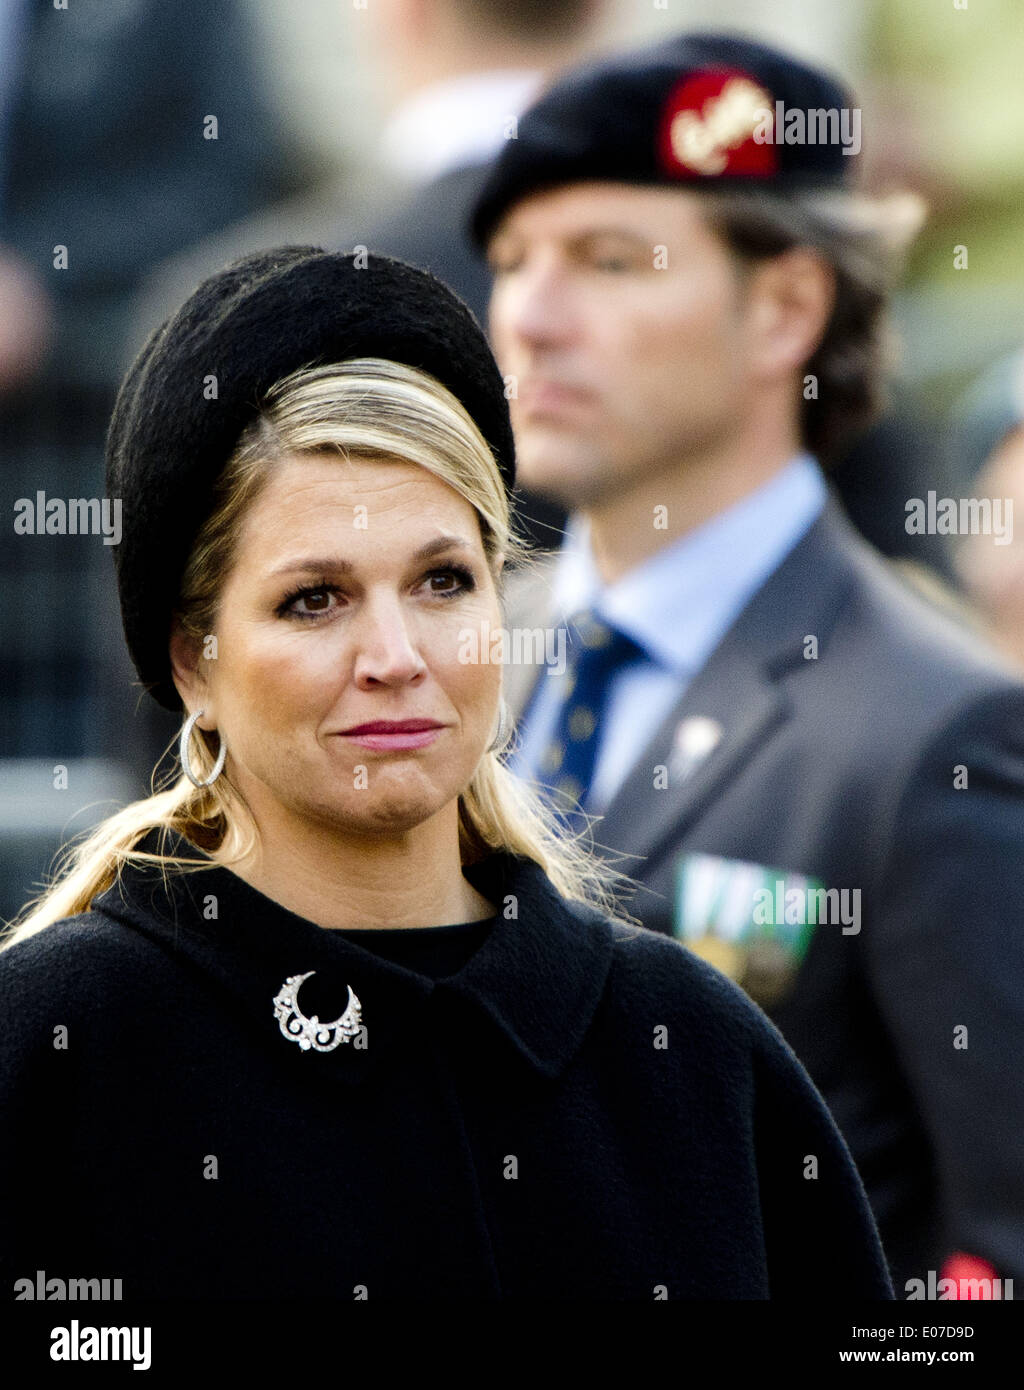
488, 182, 752, 507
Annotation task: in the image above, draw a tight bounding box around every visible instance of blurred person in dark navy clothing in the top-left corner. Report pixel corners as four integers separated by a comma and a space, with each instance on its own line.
0, 0, 289, 403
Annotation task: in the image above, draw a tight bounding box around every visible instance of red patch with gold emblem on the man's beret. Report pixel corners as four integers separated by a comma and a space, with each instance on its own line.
659, 68, 778, 178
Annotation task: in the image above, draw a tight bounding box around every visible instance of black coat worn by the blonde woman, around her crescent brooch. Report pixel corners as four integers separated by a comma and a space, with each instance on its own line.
0, 834, 892, 1300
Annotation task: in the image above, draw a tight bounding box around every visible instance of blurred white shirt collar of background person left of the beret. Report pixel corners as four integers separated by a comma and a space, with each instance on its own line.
381, 68, 543, 183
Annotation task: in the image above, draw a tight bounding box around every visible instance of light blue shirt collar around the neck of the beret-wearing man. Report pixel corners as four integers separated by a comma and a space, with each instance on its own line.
553, 453, 828, 678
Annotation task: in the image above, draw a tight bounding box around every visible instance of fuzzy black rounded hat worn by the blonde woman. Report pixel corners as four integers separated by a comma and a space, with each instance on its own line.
107, 246, 515, 710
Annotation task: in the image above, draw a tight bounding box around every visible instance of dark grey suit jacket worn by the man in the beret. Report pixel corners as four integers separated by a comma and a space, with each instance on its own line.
506, 499, 1024, 1293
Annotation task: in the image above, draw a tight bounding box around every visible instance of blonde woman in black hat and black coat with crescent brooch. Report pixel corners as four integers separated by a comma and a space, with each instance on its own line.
0, 247, 892, 1300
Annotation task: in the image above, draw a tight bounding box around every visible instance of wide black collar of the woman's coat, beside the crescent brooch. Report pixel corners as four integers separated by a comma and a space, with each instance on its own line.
92, 835, 613, 1083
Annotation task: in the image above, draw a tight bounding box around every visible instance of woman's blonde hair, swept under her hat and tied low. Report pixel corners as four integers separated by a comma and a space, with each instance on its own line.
0, 357, 628, 951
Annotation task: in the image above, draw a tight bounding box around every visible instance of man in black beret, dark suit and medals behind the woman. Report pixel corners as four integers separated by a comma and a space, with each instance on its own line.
472, 35, 1024, 1297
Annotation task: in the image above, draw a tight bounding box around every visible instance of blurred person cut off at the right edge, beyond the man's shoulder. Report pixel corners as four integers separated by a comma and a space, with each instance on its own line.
953, 353, 1024, 667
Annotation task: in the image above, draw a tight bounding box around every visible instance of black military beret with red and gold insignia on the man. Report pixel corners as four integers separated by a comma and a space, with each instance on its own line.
470, 33, 860, 247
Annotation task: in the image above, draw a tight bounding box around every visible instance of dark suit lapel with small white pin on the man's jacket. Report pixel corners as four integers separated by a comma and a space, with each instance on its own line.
593, 499, 853, 873
